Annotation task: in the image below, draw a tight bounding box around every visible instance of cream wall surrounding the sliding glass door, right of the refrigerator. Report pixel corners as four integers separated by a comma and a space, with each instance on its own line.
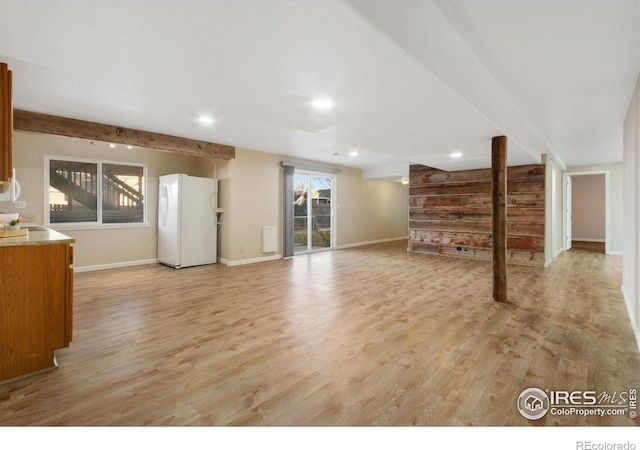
202, 148, 409, 265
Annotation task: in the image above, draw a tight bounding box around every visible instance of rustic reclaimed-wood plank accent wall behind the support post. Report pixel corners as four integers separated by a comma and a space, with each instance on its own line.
409, 165, 545, 266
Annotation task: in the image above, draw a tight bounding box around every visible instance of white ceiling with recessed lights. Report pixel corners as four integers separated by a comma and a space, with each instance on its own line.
0, 0, 640, 178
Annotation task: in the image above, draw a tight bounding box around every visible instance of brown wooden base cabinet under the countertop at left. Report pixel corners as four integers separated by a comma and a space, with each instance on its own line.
0, 243, 73, 382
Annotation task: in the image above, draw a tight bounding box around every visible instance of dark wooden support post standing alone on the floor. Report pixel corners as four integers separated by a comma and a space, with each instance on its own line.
491, 136, 507, 302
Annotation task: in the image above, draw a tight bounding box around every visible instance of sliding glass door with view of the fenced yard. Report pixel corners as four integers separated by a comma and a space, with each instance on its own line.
293, 170, 335, 254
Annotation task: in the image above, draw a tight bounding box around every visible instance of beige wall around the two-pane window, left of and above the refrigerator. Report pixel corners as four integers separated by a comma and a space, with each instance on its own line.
0, 132, 199, 268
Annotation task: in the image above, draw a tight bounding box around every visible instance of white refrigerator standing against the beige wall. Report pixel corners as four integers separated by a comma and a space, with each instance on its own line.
158, 174, 218, 268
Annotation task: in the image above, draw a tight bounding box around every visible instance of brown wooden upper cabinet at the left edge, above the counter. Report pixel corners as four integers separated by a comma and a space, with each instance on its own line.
0, 63, 13, 185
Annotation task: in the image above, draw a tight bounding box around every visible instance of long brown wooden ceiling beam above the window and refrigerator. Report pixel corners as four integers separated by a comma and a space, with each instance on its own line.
13, 109, 235, 159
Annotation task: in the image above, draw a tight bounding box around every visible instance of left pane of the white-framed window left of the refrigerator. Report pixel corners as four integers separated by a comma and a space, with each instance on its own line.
49, 160, 98, 223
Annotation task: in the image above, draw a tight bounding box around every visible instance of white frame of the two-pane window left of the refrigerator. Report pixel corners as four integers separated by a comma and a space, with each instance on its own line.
44, 155, 150, 230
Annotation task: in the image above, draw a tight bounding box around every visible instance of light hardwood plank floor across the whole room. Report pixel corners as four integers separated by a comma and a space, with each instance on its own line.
0, 242, 640, 426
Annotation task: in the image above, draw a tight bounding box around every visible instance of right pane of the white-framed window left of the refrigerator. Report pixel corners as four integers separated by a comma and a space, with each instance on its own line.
102, 163, 144, 223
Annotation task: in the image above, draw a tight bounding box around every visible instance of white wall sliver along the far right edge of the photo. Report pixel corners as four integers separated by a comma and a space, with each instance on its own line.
622, 73, 640, 347
